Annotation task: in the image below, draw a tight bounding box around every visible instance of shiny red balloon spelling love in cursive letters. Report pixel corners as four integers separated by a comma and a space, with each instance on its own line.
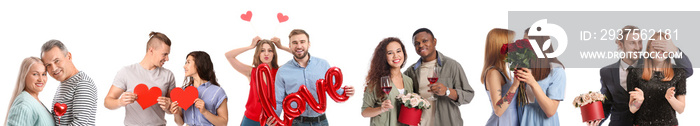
255, 64, 349, 126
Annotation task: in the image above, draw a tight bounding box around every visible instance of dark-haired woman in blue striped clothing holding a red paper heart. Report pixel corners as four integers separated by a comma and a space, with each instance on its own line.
170, 51, 228, 126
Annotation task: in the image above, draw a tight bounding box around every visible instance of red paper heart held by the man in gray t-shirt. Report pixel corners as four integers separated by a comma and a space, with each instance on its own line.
134, 84, 163, 110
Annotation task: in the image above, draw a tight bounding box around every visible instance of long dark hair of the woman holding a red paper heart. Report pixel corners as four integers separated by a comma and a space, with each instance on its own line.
182, 51, 221, 88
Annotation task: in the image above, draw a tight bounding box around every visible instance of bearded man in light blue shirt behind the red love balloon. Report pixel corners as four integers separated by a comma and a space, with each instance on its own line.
275, 29, 355, 126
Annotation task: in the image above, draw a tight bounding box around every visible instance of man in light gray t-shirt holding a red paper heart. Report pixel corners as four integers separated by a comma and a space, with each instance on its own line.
104, 32, 175, 125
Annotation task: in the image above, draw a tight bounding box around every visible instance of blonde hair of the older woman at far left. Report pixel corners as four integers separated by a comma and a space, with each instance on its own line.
4, 57, 44, 124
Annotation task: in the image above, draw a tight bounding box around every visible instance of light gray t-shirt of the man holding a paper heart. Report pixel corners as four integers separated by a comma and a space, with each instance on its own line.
113, 63, 175, 126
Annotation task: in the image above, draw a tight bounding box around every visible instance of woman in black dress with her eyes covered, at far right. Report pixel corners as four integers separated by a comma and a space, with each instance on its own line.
627, 33, 687, 126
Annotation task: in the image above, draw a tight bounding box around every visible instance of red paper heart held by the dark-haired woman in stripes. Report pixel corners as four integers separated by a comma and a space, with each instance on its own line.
170, 86, 199, 110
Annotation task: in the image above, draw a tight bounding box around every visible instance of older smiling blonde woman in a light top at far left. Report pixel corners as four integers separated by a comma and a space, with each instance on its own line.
5, 57, 55, 126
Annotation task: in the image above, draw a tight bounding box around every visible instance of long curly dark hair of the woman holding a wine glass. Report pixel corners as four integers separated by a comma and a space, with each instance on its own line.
365, 37, 406, 99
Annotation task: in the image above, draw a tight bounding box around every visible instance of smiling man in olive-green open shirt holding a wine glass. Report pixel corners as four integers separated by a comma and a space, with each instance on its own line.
404, 28, 474, 126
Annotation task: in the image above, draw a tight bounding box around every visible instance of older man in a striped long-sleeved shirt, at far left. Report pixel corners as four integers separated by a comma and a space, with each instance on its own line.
41, 40, 97, 126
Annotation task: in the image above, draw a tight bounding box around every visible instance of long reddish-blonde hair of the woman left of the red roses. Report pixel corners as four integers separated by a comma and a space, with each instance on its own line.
481, 28, 515, 84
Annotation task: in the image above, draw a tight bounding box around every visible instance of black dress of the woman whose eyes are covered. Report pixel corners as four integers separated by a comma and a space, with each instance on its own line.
627, 66, 687, 126
